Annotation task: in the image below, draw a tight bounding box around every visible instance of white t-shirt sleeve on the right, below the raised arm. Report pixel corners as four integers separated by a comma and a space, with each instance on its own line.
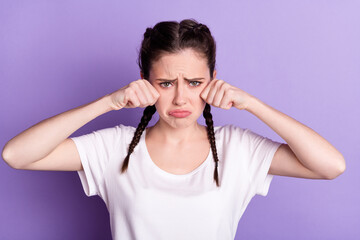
244, 129, 282, 196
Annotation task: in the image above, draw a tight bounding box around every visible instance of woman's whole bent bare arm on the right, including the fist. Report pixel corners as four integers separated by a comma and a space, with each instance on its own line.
200, 79, 346, 179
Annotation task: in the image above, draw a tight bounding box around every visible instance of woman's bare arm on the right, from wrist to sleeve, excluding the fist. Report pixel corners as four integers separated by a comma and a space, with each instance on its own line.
246, 97, 346, 179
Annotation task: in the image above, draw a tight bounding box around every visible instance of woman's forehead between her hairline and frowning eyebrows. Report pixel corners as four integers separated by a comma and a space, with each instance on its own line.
150, 49, 209, 78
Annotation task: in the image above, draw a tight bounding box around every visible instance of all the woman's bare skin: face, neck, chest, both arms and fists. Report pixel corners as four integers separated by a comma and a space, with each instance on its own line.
2, 49, 346, 179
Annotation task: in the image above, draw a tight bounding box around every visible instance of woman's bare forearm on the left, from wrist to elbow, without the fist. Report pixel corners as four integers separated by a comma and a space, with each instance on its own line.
2, 95, 112, 170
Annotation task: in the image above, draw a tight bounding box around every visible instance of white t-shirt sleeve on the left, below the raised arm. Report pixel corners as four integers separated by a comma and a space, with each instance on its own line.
70, 126, 119, 197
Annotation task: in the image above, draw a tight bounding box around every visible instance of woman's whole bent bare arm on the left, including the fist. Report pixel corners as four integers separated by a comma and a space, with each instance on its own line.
2, 79, 160, 171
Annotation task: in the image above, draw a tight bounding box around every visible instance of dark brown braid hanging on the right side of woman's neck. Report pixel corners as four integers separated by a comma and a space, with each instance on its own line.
203, 103, 220, 187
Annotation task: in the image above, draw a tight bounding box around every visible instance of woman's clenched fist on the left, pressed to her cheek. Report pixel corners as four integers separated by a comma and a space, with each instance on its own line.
110, 79, 160, 110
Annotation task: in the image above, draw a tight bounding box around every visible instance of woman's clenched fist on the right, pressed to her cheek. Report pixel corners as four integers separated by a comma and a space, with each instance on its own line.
200, 79, 251, 110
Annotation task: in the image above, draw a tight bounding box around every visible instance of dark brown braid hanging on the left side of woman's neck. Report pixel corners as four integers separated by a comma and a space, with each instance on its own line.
121, 105, 156, 173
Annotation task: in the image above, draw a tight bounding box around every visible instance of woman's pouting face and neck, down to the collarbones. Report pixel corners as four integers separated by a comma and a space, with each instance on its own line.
144, 49, 216, 145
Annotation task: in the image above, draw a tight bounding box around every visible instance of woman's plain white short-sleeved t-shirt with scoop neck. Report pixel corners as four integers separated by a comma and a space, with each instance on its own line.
71, 124, 281, 240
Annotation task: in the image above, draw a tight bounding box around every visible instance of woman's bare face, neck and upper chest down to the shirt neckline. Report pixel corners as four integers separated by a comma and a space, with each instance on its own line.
137, 49, 216, 174
